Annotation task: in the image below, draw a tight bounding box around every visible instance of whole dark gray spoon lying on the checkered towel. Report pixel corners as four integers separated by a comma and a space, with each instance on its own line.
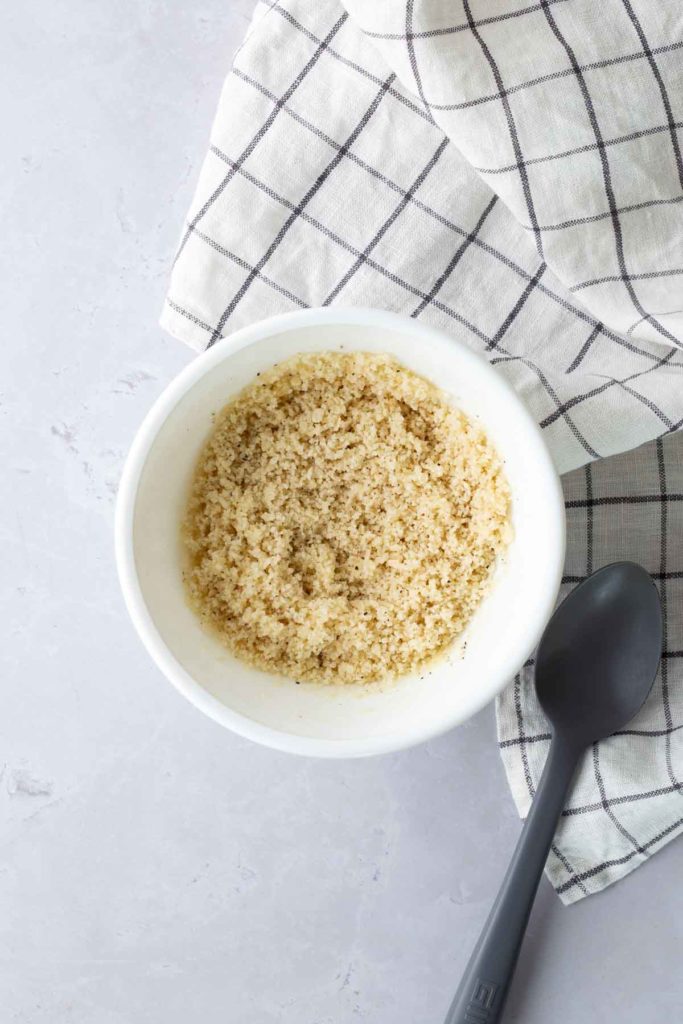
445, 562, 663, 1024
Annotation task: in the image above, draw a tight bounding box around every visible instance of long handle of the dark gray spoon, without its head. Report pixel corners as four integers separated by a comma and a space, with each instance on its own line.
444, 736, 581, 1024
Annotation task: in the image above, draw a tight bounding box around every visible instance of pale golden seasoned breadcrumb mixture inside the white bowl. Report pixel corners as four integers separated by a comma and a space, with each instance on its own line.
183, 352, 510, 683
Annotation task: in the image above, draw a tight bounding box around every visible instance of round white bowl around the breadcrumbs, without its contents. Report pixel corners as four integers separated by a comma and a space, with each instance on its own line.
116, 309, 564, 757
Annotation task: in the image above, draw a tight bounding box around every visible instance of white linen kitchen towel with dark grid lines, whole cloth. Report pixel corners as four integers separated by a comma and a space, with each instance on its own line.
162, 0, 683, 902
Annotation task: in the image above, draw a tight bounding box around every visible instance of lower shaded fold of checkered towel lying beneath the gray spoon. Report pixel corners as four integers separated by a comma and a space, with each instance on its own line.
497, 432, 683, 903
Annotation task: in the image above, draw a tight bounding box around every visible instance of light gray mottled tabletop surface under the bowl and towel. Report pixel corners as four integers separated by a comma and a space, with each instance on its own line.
0, 0, 683, 1024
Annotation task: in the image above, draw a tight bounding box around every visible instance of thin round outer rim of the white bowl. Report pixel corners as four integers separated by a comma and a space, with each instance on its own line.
115, 306, 566, 758
